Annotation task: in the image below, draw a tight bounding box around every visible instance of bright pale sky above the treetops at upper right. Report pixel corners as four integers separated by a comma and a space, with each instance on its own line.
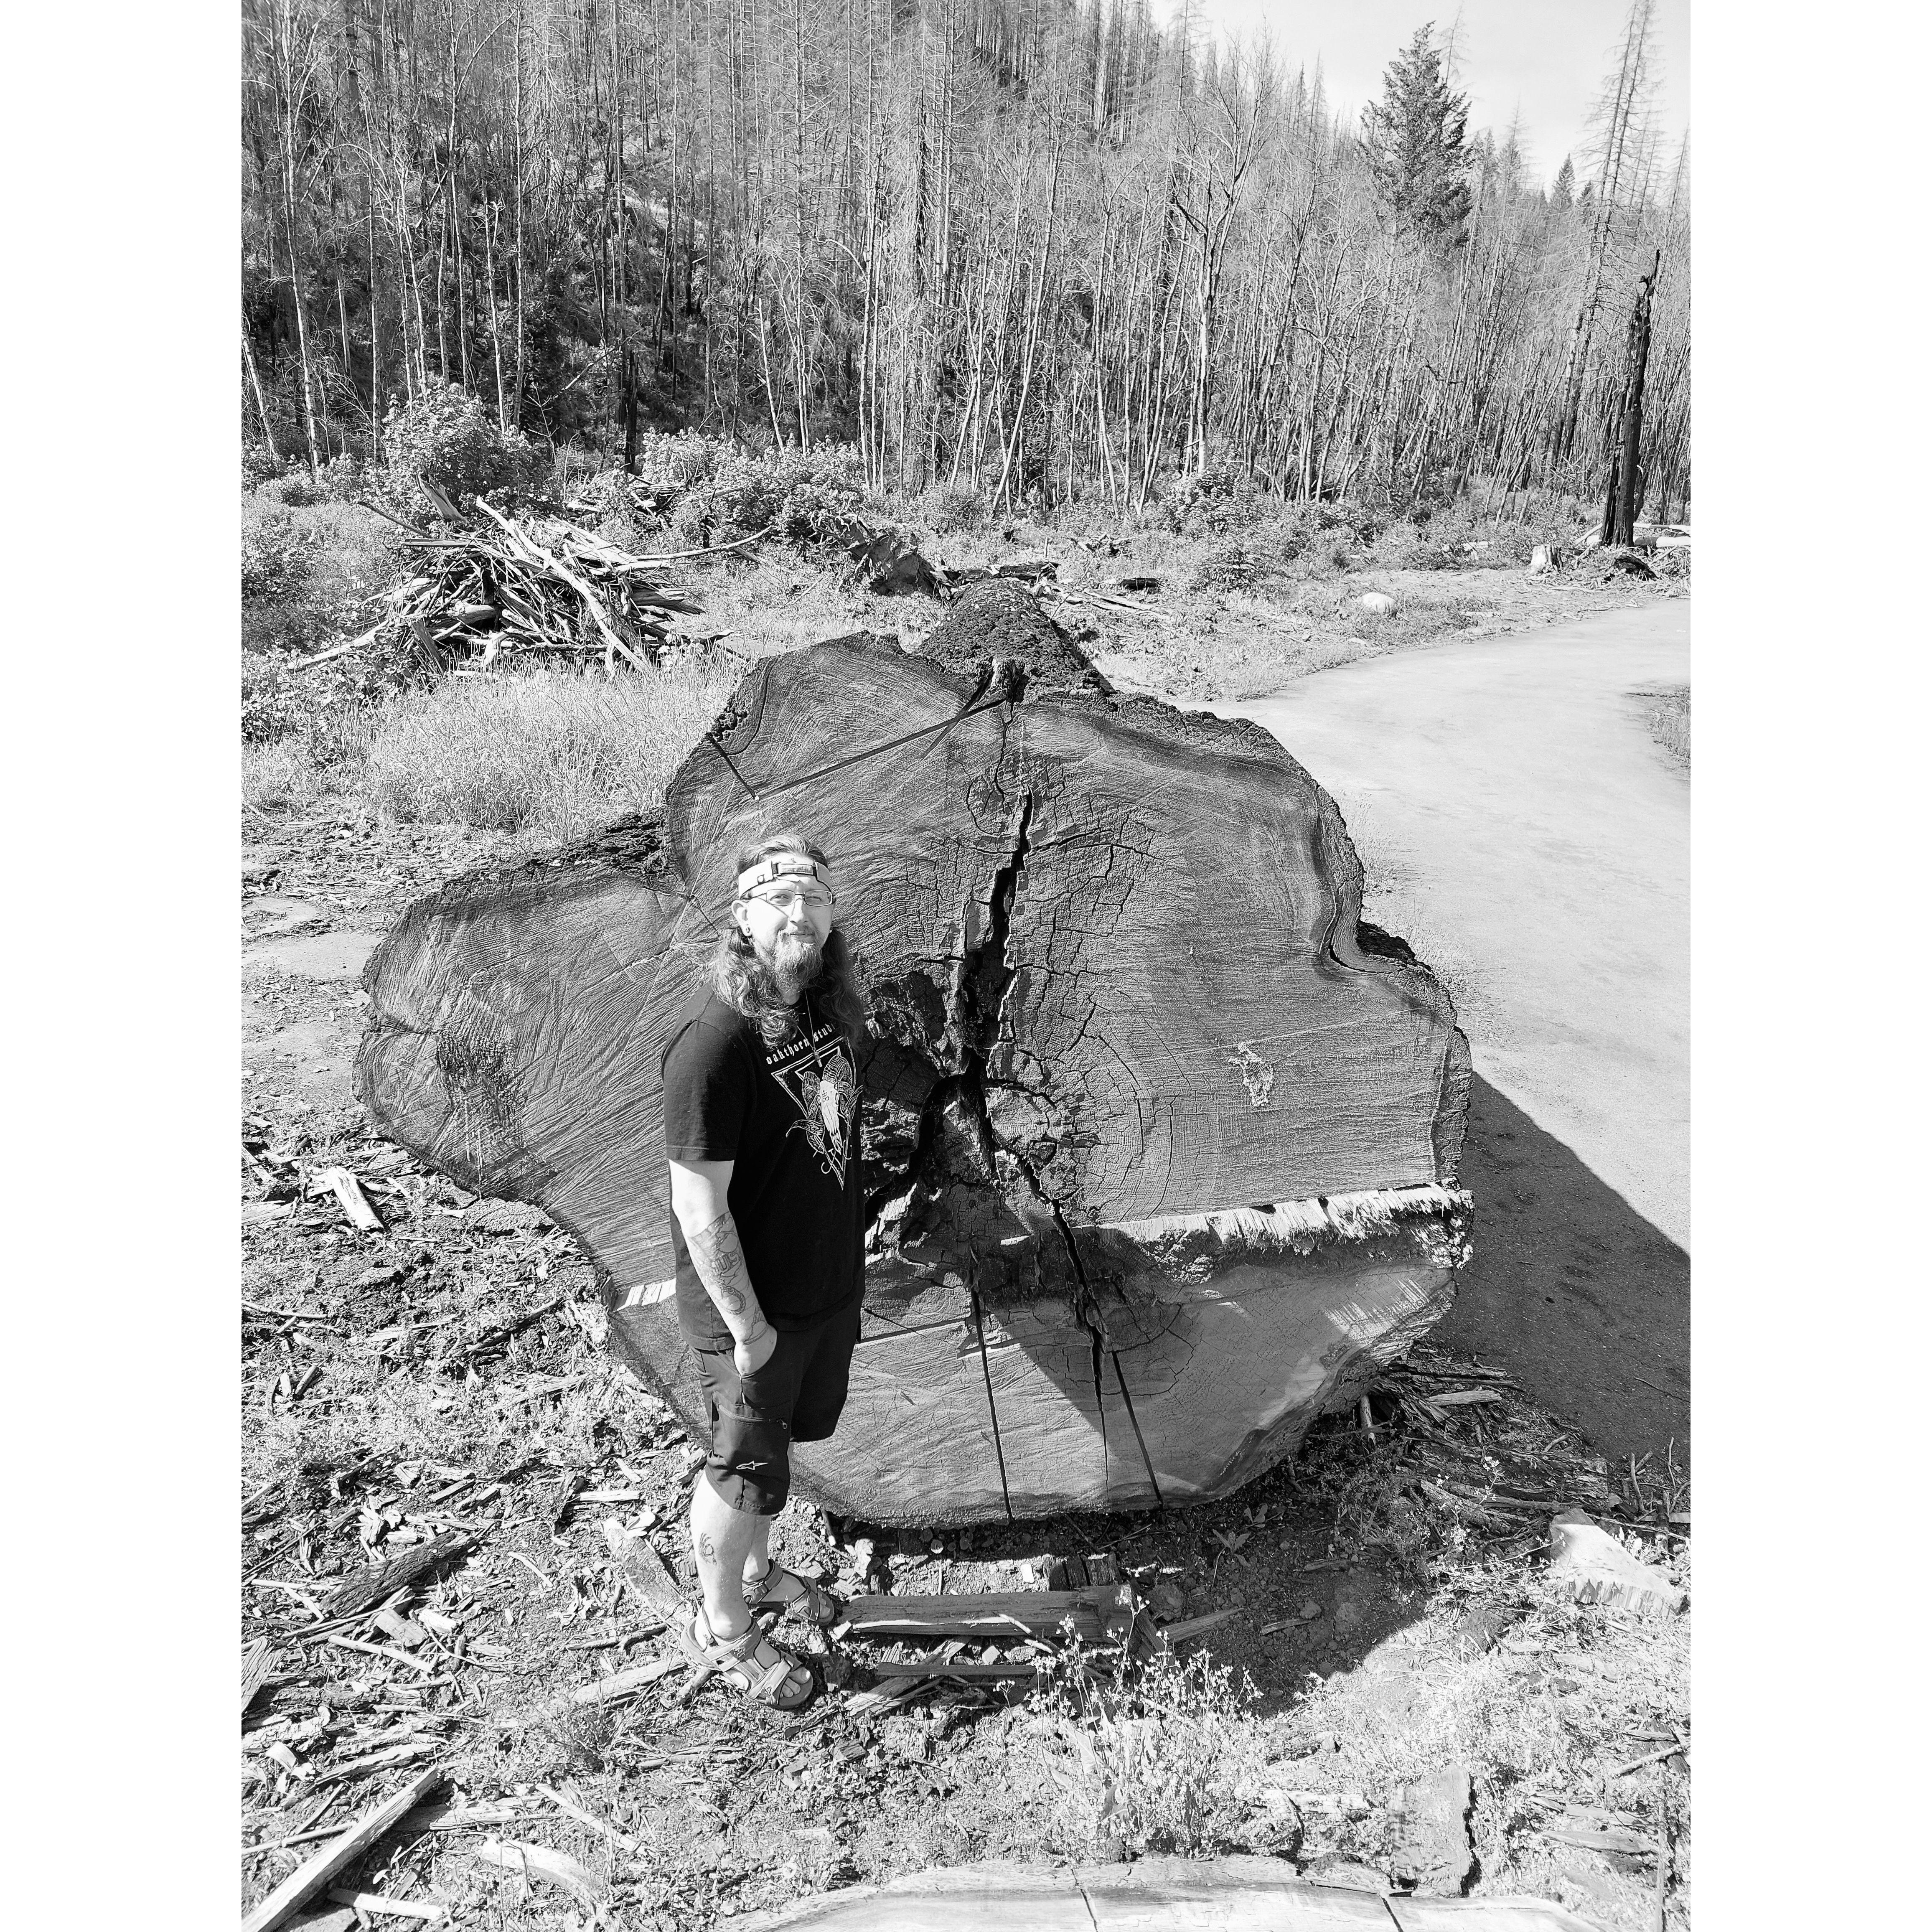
1165, 0, 1690, 182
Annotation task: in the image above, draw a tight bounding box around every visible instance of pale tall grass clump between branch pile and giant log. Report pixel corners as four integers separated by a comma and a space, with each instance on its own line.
369, 659, 736, 836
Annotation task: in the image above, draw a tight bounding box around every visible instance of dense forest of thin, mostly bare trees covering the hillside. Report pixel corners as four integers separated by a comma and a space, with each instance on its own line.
239, 0, 1690, 518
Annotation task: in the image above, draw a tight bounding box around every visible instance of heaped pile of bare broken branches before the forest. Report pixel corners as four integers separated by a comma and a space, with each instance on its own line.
313, 491, 699, 671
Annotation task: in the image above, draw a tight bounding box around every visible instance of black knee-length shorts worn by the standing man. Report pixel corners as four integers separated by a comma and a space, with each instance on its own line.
684, 1294, 860, 1517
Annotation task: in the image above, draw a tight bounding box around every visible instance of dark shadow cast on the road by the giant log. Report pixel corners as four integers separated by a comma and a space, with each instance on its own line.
1430, 1076, 1690, 1467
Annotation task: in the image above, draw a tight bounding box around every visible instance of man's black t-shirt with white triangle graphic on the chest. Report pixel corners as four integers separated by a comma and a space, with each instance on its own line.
663, 989, 866, 1349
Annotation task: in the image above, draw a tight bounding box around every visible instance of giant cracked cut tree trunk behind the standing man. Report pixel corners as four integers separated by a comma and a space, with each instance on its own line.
357, 583, 1468, 1524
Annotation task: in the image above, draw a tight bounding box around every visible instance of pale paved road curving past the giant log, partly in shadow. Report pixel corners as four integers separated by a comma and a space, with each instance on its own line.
1217, 601, 1690, 1459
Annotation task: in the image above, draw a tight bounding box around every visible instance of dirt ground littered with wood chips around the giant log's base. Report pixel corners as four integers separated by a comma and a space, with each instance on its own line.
242, 572, 1690, 1932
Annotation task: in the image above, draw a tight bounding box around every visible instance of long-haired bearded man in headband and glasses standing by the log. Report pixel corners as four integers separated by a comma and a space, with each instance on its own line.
663, 833, 866, 1710
